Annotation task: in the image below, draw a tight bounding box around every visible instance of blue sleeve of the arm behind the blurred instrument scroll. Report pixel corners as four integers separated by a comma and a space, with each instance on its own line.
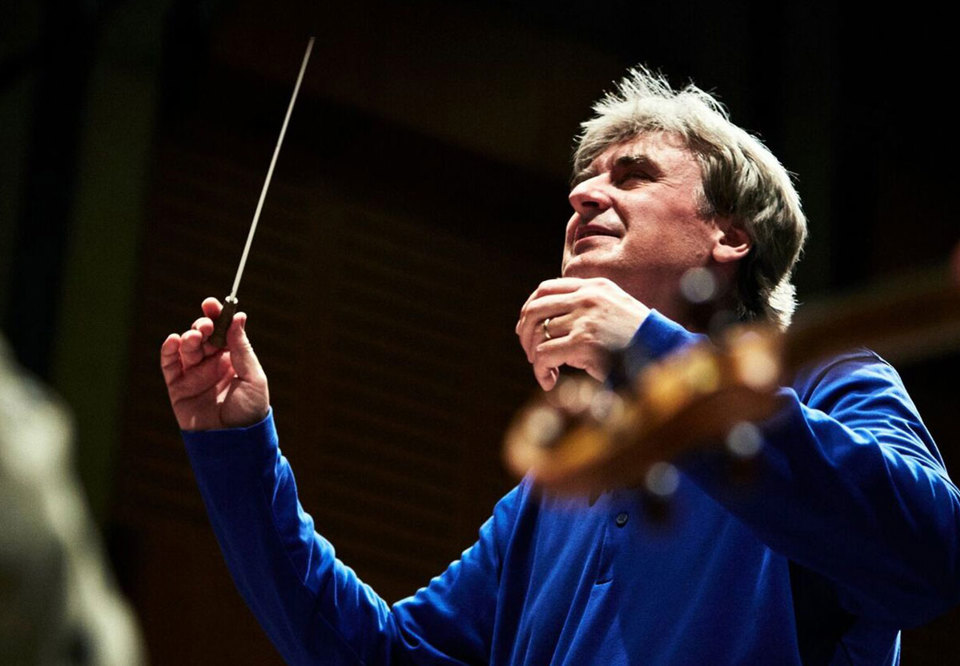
635, 308, 960, 627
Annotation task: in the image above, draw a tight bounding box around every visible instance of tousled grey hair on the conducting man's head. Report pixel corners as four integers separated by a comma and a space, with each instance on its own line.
573, 66, 807, 329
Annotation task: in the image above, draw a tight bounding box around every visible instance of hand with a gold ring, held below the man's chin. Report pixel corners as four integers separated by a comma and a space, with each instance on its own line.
516, 278, 650, 391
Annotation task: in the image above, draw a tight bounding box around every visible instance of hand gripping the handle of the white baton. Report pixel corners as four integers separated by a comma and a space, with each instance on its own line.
160, 298, 270, 430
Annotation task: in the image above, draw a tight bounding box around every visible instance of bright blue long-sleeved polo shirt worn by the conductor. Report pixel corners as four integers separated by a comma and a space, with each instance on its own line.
183, 312, 960, 665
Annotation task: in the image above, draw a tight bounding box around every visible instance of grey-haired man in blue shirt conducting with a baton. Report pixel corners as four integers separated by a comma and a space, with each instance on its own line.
161, 69, 960, 664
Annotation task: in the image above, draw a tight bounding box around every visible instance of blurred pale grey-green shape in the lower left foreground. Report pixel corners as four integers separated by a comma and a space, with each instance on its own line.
0, 339, 144, 666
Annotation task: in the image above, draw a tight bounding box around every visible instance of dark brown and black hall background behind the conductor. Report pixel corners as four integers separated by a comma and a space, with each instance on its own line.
0, 0, 960, 664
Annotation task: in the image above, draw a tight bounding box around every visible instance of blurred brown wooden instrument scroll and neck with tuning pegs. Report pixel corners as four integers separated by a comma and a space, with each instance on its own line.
504, 262, 960, 499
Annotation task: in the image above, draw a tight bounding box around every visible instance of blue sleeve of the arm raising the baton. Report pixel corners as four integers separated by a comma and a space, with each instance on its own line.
183, 413, 515, 664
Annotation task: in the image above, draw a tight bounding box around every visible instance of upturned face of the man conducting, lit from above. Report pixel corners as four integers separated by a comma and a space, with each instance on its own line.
563, 132, 723, 317
